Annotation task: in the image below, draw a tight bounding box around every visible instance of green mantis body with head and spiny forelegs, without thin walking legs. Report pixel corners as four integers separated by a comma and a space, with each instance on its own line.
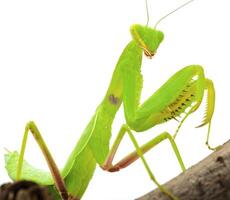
6, 25, 214, 199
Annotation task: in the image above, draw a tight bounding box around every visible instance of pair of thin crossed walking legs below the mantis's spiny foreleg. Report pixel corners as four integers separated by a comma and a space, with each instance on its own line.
101, 125, 185, 200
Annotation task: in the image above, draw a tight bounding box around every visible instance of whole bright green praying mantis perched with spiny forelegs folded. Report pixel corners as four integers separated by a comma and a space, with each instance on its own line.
5, 1, 215, 200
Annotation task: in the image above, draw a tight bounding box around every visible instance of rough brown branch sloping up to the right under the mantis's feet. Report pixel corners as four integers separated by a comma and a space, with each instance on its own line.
137, 141, 230, 200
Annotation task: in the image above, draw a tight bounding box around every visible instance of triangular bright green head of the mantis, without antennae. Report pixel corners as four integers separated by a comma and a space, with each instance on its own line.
130, 24, 164, 58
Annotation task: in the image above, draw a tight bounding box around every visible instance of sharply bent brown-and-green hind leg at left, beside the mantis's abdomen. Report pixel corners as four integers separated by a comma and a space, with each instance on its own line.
16, 121, 69, 200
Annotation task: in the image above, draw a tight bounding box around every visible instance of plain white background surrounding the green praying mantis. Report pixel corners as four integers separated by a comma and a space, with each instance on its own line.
0, 0, 230, 200
